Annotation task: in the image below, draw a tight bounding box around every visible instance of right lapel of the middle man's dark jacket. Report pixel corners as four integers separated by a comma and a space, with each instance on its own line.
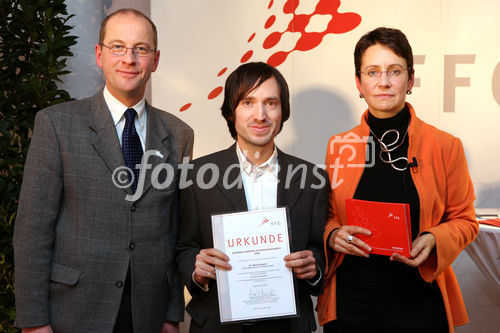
276, 149, 302, 211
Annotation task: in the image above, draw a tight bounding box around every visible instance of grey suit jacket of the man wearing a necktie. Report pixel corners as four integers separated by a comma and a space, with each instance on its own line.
14, 93, 193, 333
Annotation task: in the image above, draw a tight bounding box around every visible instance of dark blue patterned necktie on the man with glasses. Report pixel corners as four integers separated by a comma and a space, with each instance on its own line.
122, 109, 143, 193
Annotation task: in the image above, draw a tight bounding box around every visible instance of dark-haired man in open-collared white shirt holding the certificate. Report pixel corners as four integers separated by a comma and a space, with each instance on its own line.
177, 62, 329, 333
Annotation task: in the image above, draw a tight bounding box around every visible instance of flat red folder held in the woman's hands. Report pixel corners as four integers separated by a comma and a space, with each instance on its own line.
346, 199, 411, 257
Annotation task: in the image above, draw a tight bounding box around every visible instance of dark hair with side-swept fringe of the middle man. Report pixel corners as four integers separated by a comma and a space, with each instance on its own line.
221, 62, 290, 140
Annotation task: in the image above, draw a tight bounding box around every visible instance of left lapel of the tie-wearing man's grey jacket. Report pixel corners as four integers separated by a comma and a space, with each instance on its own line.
88, 92, 131, 193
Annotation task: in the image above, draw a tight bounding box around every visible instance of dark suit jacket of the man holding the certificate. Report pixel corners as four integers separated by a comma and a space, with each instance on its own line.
177, 145, 329, 333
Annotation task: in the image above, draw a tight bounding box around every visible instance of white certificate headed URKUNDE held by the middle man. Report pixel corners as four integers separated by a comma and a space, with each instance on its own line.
212, 207, 298, 323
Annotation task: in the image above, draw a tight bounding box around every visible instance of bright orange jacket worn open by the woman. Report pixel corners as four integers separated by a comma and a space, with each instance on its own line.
318, 104, 479, 332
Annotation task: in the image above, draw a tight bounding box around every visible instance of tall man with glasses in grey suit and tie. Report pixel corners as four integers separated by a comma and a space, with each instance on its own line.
14, 9, 193, 333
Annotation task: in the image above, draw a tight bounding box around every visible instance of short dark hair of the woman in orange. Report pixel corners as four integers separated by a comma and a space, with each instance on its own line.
354, 27, 413, 79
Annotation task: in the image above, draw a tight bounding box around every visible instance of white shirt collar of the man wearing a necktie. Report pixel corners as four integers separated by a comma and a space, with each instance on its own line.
103, 87, 148, 151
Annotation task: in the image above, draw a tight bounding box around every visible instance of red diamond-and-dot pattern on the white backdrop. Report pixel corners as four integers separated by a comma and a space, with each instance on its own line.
179, 0, 361, 112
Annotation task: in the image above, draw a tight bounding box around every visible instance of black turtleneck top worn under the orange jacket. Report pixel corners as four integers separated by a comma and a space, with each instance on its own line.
337, 106, 434, 313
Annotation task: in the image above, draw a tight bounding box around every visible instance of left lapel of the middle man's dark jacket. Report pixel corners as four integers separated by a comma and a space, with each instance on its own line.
216, 143, 248, 211
